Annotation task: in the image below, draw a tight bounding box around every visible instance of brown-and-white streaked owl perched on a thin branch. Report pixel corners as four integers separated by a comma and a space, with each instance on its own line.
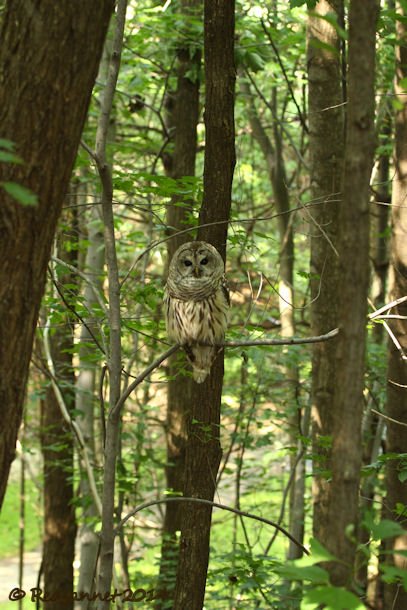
164, 241, 229, 383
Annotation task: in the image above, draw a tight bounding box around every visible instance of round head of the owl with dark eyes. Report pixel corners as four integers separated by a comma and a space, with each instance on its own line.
167, 241, 225, 300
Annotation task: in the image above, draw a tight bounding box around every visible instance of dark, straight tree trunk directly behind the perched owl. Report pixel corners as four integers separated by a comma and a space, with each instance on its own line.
174, 0, 235, 610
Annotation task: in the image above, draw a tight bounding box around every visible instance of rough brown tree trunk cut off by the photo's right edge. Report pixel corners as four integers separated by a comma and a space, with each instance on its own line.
384, 4, 407, 610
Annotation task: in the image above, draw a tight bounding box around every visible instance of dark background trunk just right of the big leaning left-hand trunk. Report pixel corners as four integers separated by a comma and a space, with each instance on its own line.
41, 207, 77, 610
